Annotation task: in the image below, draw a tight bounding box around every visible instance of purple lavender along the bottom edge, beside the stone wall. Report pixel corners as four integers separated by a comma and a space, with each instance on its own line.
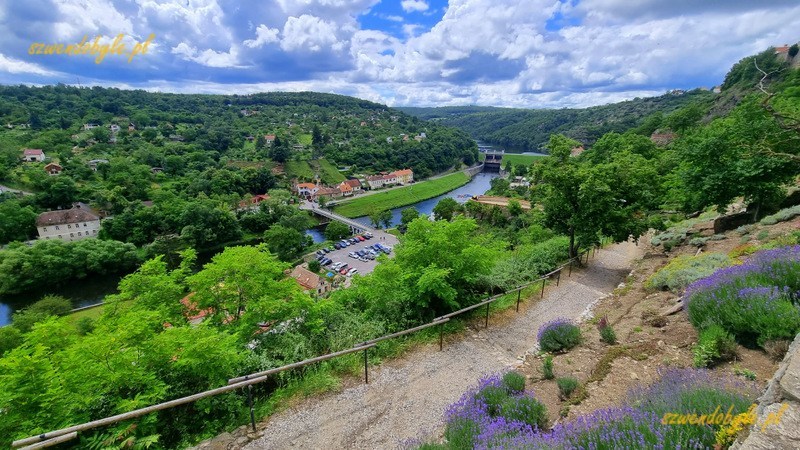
432, 369, 759, 450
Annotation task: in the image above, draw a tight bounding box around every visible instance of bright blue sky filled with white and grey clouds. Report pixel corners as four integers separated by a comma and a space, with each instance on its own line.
0, 0, 800, 108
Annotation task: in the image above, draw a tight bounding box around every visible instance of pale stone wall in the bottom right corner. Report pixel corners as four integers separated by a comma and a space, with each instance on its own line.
731, 334, 800, 450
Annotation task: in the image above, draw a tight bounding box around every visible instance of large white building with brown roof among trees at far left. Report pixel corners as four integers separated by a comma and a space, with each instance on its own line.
36, 203, 100, 241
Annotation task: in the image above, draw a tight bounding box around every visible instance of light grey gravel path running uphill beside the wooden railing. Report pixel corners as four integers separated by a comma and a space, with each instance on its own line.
244, 243, 641, 450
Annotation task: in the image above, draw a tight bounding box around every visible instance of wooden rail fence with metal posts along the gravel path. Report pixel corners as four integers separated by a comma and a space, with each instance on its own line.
11, 246, 600, 450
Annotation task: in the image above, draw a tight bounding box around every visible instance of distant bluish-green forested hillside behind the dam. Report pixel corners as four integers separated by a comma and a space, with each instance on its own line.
400, 89, 714, 151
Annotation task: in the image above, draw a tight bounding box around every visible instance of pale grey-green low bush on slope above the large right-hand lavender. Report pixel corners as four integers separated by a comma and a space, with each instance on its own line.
645, 253, 732, 292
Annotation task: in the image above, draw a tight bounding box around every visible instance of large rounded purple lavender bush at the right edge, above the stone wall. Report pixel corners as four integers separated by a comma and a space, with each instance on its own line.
686, 246, 800, 346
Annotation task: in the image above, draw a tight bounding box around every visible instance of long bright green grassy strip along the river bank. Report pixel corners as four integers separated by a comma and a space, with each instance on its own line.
333, 172, 470, 217
